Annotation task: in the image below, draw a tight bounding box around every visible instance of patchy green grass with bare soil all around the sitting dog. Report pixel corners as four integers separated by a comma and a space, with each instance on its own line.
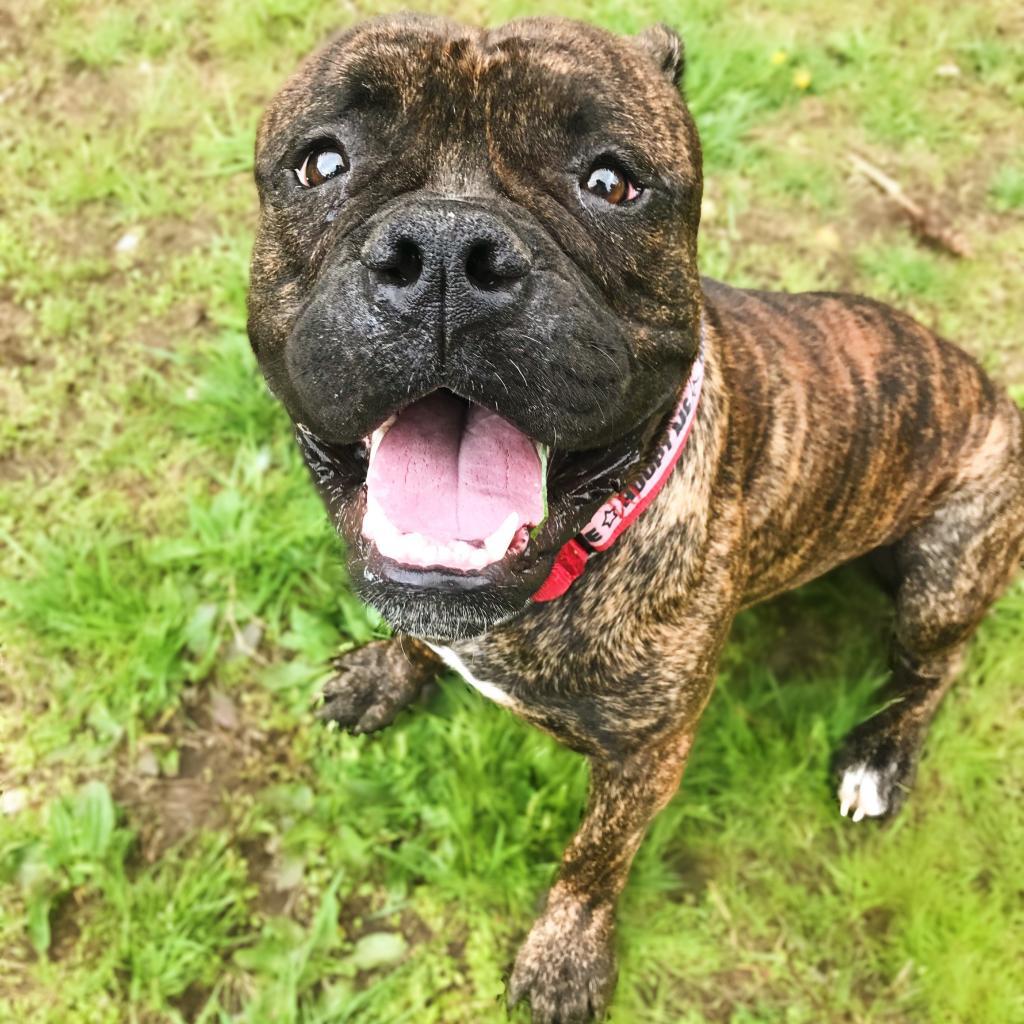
0, 0, 1024, 1024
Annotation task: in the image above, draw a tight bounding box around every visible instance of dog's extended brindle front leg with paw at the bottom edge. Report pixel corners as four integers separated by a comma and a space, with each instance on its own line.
508, 728, 693, 1024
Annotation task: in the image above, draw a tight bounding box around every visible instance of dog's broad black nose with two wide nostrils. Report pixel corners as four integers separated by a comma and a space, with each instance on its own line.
360, 200, 530, 328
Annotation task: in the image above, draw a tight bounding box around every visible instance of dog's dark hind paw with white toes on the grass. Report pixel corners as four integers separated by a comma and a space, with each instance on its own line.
836, 706, 922, 821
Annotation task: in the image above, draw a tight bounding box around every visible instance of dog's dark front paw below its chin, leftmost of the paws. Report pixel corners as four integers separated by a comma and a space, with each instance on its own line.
316, 640, 434, 736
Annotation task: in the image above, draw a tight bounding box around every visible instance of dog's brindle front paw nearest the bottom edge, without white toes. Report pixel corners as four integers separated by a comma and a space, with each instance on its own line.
508, 900, 615, 1024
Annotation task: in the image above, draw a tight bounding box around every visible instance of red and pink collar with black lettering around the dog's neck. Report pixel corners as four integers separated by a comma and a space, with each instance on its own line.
532, 340, 705, 602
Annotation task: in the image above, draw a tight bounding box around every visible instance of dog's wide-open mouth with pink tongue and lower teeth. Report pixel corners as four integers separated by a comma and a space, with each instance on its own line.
362, 390, 547, 572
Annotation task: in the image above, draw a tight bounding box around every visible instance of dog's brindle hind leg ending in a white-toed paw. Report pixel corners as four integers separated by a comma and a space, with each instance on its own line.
835, 407, 1024, 821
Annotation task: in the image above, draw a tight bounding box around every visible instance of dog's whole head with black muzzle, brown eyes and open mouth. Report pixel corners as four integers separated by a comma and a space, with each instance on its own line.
249, 17, 701, 639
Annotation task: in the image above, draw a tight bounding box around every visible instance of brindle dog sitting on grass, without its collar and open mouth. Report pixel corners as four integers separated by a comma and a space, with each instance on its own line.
249, 16, 1024, 1022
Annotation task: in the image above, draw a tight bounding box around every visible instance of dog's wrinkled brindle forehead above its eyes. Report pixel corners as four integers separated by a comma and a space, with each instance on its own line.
258, 16, 692, 176
